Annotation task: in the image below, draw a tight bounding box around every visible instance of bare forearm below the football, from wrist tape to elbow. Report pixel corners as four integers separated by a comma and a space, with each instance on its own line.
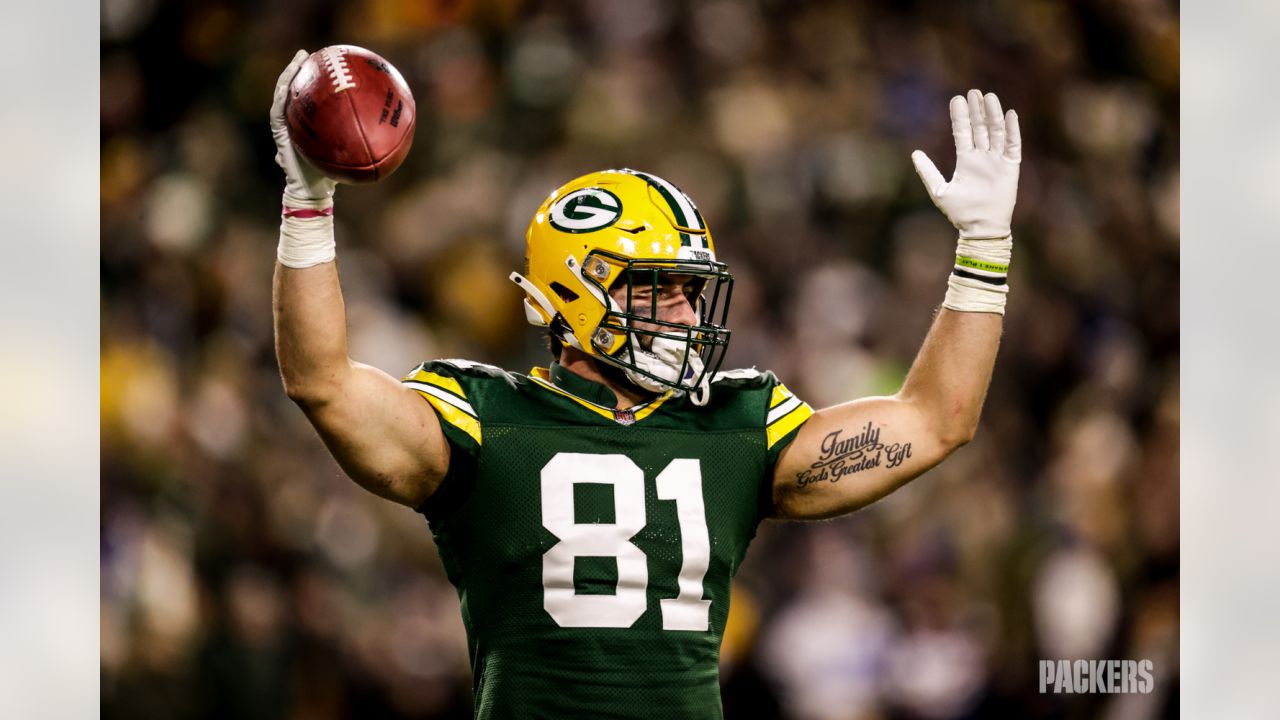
271, 261, 351, 405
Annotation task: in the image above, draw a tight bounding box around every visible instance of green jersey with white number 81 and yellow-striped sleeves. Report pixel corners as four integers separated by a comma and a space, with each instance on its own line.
403, 360, 813, 720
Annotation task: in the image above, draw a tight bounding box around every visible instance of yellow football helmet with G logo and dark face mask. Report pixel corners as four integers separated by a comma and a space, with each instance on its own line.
511, 169, 733, 405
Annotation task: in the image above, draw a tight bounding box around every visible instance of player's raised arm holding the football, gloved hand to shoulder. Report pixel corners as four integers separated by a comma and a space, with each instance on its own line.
271, 51, 449, 507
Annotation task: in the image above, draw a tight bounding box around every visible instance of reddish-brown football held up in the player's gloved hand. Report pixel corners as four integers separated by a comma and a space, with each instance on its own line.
284, 45, 417, 183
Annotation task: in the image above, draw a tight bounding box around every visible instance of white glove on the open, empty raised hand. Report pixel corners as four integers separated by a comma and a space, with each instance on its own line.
911, 90, 1023, 240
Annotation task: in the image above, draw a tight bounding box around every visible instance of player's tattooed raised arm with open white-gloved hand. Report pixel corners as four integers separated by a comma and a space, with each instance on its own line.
773, 90, 1021, 519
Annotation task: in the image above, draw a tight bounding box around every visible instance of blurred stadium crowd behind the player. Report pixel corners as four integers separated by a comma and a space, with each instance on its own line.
100, 0, 1179, 720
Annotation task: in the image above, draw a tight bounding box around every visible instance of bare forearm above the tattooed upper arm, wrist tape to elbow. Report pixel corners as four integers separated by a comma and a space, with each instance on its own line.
897, 307, 1004, 447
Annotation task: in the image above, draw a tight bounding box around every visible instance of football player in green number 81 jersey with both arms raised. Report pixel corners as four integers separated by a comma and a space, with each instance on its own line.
271, 47, 1021, 719
